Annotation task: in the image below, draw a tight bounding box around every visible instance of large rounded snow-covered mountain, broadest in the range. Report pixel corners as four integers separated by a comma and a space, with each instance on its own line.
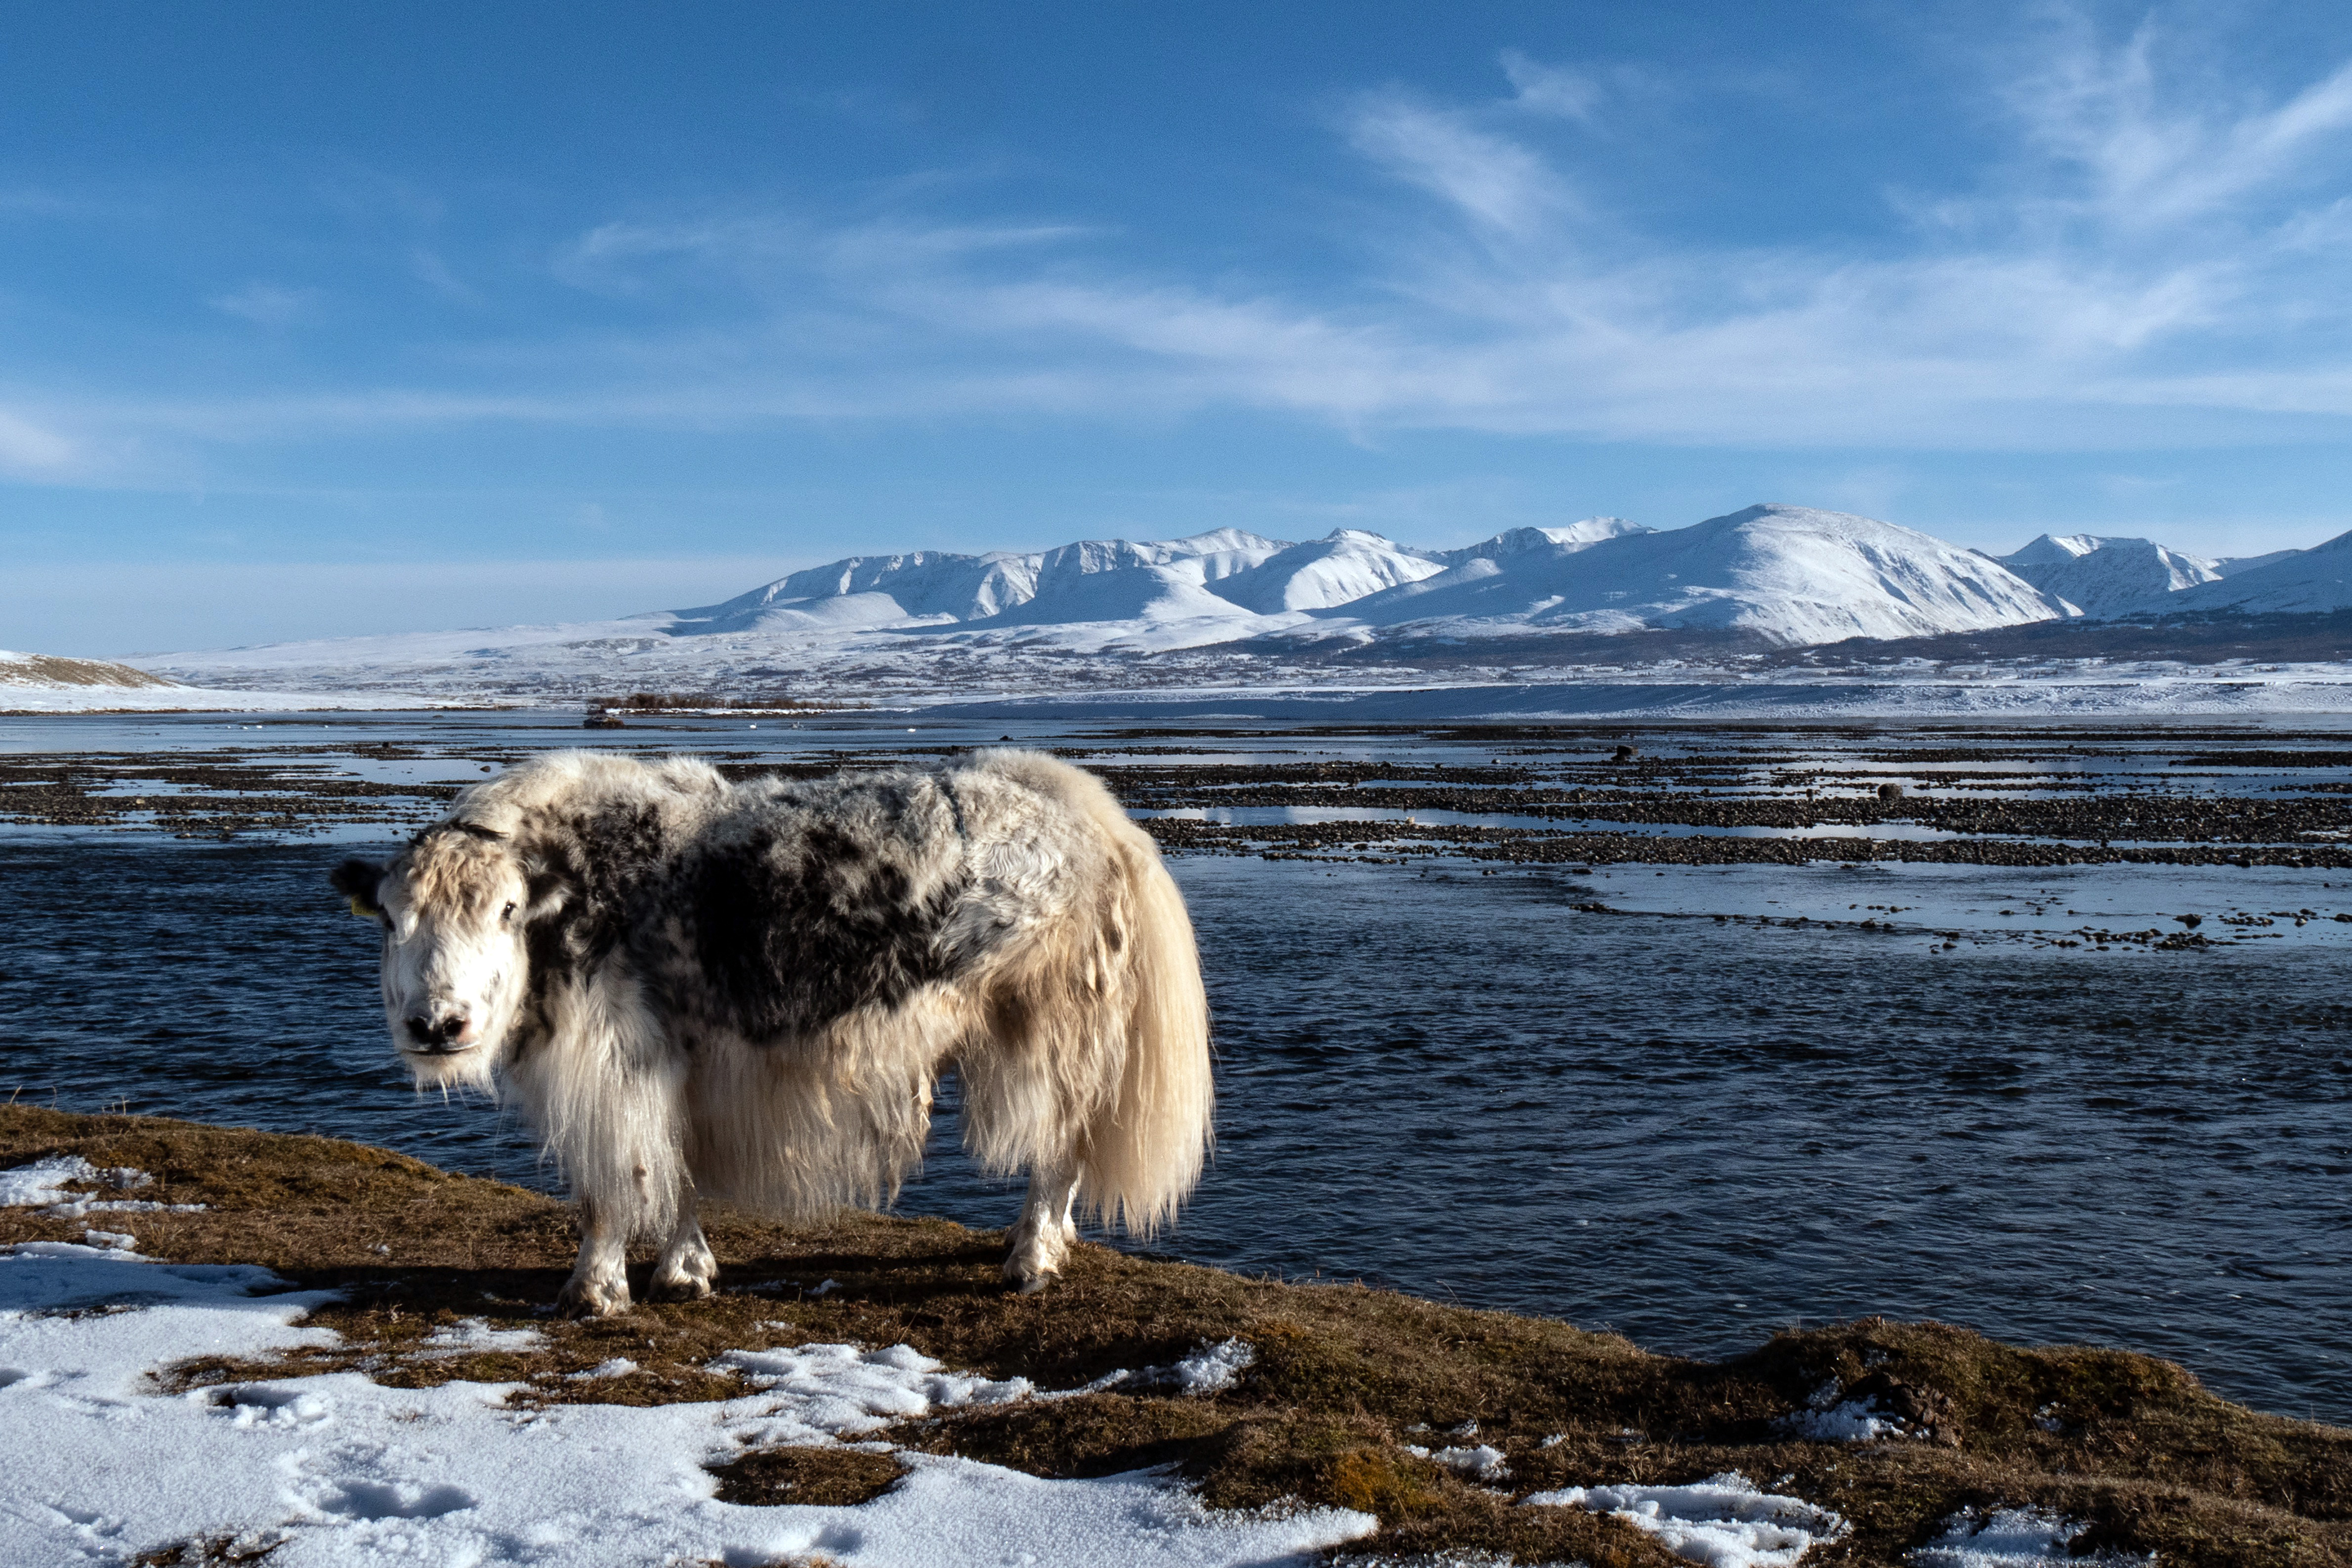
1345, 506, 2065, 644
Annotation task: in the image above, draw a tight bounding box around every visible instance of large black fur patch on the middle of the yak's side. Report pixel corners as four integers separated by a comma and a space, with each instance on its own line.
682, 780, 966, 1041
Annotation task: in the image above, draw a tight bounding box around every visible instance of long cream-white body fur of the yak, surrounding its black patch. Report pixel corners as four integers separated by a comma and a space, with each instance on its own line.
378, 750, 1214, 1236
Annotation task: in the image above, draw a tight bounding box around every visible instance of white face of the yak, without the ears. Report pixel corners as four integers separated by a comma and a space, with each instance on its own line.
377, 858, 529, 1091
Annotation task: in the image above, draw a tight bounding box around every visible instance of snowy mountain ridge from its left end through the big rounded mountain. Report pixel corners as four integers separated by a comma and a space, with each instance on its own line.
668, 506, 2072, 649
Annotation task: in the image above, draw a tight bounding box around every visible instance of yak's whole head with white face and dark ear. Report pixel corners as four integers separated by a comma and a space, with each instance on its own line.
332, 823, 562, 1091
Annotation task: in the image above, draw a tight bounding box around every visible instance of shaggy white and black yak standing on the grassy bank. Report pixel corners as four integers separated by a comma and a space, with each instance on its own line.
334, 750, 1211, 1314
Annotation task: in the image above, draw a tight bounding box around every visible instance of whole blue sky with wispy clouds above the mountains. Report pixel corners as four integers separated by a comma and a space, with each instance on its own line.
0, 0, 2352, 653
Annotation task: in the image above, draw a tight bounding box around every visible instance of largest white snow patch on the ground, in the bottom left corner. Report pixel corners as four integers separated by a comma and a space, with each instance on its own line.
0, 1250, 1376, 1568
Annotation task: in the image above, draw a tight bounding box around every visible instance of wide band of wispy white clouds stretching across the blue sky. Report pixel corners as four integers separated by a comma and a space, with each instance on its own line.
13, 14, 2352, 472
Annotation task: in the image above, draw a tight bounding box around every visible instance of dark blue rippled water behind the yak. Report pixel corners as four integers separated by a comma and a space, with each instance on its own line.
0, 717, 2352, 1422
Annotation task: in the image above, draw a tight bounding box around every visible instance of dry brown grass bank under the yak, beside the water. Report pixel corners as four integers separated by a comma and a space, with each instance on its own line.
0, 1107, 2352, 1568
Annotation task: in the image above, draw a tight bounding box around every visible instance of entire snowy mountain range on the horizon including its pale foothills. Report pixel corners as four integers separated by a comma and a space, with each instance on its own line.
141, 506, 2323, 693
